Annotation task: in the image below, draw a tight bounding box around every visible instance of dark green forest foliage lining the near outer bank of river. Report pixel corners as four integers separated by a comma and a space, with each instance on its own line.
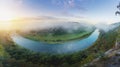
0, 23, 120, 67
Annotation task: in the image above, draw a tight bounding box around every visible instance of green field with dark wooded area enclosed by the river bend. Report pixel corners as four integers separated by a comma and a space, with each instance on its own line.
20, 23, 95, 44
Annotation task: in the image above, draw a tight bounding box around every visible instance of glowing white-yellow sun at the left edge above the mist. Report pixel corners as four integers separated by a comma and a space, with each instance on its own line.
0, 10, 16, 30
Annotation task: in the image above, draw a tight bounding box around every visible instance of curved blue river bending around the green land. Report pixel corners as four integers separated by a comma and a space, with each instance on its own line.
11, 29, 100, 54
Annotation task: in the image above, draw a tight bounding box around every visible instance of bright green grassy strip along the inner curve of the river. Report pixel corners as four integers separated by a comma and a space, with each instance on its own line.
23, 30, 94, 44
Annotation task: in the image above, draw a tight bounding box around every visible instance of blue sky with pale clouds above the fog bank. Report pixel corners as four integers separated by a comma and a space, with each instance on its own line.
0, 0, 120, 24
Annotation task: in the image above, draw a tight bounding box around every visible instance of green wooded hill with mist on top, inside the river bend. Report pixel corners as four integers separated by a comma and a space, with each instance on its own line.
19, 22, 95, 43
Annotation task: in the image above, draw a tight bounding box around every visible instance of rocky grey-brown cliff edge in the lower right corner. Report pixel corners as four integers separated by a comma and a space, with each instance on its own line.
85, 26, 120, 67
